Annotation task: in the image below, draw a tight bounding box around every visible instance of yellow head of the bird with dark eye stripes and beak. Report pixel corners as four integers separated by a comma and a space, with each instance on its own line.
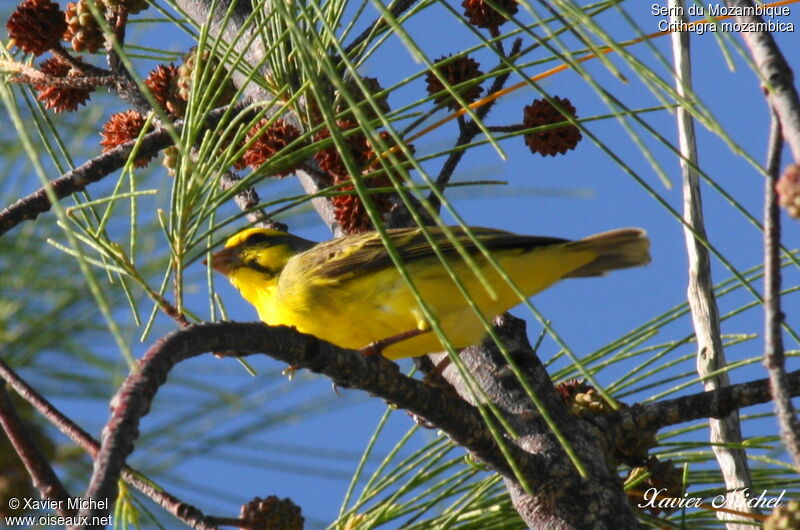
211, 228, 314, 283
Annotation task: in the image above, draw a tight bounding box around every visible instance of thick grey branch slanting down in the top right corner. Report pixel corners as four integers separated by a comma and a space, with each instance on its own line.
725, 0, 800, 163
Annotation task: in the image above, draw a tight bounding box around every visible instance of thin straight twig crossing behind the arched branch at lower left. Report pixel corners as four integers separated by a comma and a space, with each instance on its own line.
0, 359, 215, 530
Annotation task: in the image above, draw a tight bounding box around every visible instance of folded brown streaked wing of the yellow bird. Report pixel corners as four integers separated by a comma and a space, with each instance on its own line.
302, 227, 567, 280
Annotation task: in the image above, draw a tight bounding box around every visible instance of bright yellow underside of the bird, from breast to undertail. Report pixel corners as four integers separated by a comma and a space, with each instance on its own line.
254, 249, 594, 359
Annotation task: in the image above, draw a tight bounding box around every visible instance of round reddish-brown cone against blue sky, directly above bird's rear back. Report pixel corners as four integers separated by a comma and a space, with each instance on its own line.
523, 96, 581, 156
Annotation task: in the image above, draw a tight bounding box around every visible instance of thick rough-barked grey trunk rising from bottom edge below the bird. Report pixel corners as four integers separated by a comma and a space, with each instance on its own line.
434, 315, 639, 529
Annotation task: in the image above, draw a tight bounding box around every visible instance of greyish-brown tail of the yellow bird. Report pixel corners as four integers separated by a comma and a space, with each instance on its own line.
566, 228, 650, 278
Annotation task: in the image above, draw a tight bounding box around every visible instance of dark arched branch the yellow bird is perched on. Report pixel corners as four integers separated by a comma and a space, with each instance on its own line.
75, 322, 547, 519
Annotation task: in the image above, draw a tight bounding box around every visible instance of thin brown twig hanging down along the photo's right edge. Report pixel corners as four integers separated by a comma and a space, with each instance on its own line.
764, 109, 800, 470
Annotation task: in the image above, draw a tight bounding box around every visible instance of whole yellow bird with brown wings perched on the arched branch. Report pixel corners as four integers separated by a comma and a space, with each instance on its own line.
211, 227, 650, 359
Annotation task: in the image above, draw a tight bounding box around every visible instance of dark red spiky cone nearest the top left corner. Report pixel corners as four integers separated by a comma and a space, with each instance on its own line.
6, 0, 67, 56
